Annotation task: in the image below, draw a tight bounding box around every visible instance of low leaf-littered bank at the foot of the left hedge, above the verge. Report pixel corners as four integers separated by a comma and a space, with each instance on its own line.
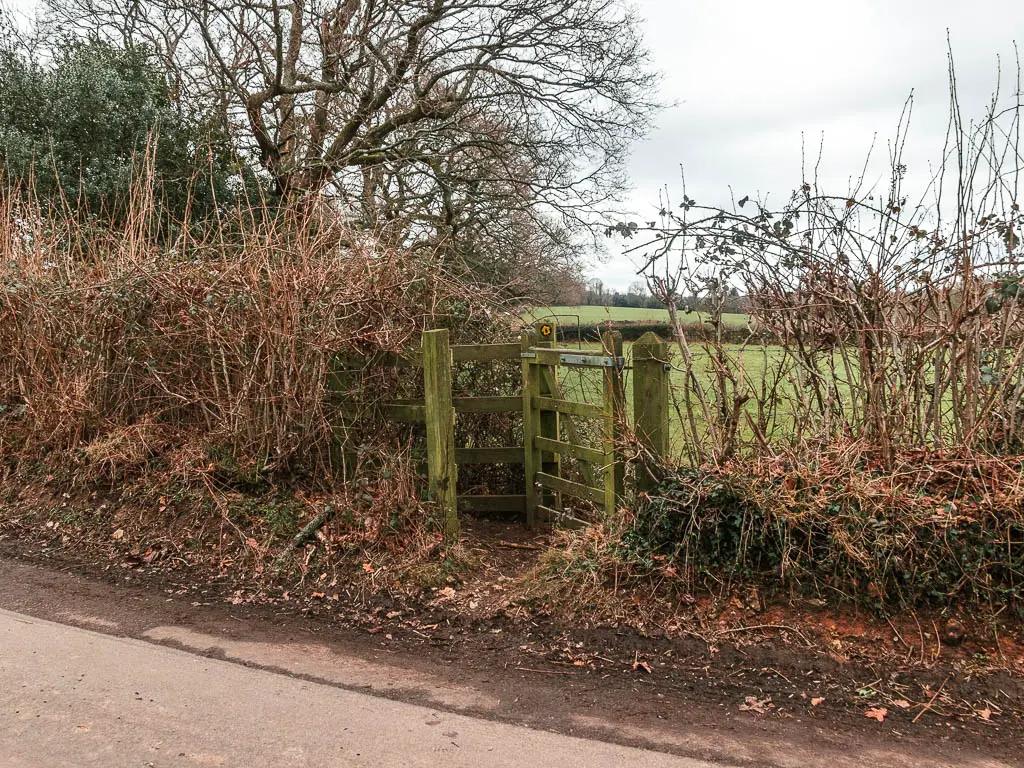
0, 438, 466, 598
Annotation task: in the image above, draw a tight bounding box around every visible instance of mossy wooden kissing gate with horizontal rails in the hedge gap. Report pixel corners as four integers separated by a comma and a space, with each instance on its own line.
332, 324, 647, 541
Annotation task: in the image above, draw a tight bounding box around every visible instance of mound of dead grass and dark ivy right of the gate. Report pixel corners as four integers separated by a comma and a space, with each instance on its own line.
535, 445, 1024, 622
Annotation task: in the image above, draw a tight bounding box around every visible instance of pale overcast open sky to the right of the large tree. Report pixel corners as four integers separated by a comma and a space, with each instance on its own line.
592, 0, 1024, 288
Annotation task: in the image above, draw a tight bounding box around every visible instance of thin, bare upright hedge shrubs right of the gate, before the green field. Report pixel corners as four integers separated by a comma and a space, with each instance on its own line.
614, 53, 1024, 466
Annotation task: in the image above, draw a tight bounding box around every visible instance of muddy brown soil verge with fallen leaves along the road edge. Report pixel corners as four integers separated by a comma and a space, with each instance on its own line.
0, 520, 1024, 766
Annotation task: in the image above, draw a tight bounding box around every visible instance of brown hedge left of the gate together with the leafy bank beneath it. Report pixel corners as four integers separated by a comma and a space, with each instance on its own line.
0, 160, 516, 593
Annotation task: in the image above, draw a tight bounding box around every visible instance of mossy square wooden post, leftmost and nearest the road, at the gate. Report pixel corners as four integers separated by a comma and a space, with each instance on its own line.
423, 329, 459, 544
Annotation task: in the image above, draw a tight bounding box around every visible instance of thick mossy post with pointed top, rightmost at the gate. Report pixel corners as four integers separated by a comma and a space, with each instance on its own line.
633, 331, 669, 494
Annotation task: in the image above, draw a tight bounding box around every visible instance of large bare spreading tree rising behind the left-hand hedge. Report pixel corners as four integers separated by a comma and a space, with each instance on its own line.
47, 0, 656, 288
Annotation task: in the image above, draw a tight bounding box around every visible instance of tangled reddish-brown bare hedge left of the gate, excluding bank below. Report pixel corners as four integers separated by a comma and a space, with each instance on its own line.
0, 166, 512, 481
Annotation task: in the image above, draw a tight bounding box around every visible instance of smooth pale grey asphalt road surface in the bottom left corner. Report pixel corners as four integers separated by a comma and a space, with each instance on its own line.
0, 610, 724, 768
